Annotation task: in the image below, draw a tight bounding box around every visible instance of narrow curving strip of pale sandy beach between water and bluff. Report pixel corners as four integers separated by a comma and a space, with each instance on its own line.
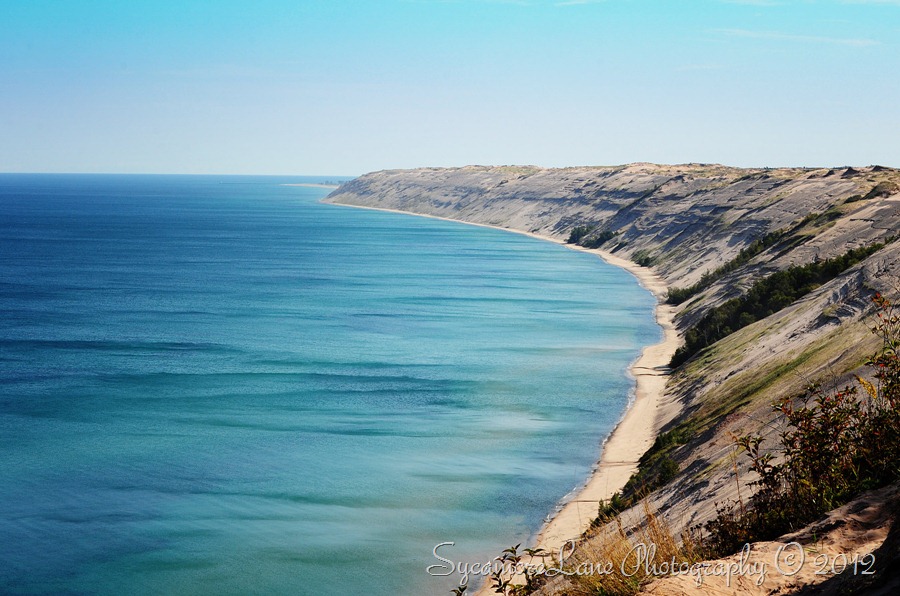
326, 203, 679, 594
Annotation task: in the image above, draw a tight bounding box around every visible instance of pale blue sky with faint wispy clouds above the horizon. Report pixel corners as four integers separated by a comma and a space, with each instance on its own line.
0, 0, 900, 175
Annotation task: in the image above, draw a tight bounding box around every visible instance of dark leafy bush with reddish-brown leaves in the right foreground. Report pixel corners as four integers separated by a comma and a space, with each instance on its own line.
706, 294, 900, 554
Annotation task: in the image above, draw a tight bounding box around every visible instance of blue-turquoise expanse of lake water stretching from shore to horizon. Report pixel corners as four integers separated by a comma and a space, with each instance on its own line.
0, 175, 660, 594
